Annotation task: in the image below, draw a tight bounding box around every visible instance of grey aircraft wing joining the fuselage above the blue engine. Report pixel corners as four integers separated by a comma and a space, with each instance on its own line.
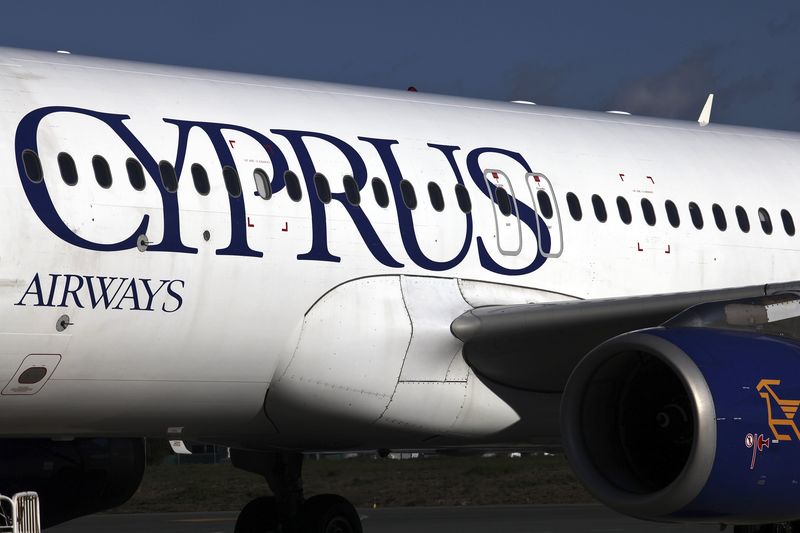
450, 282, 800, 392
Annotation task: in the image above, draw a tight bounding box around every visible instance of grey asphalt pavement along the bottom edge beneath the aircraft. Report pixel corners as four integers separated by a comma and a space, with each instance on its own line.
47, 505, 719, 533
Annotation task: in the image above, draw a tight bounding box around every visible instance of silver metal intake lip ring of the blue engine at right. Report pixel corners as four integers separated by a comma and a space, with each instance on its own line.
561, 328, 717, 518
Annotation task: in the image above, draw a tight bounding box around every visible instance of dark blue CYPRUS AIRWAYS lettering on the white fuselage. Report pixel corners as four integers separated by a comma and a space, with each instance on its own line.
15, 107, 551, 276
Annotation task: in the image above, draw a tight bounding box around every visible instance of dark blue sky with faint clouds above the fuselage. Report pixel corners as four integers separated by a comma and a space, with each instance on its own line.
0, 0, 800, 130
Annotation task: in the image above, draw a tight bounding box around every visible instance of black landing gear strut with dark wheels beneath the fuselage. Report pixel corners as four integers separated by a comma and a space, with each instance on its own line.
231, 450, 362, 533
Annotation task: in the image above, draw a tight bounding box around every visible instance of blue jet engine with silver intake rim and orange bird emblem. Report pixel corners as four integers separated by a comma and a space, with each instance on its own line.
561, 327, 800, 524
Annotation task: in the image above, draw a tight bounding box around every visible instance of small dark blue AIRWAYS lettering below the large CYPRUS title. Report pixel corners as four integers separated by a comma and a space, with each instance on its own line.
14, 272, 186, 313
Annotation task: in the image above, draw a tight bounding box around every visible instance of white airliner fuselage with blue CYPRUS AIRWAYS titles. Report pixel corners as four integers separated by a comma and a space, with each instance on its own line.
0, 50, 800, 450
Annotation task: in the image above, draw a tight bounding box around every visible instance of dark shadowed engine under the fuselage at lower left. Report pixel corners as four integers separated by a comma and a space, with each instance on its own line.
0, 439, 145, 527
